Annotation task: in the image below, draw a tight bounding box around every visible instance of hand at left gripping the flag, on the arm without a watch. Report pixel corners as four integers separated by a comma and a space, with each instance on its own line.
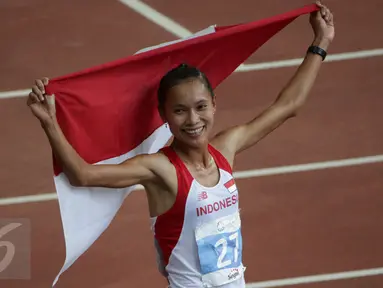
27, 77, 56, 124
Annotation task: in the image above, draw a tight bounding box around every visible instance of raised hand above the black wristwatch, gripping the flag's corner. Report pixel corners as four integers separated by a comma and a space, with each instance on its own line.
310, 2, 335, 49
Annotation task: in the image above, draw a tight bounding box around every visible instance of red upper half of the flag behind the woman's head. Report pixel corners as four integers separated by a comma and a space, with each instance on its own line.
46, 5, 318, 175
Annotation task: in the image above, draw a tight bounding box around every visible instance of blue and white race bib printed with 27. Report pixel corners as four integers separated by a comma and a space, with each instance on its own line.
195, 212, 245, 287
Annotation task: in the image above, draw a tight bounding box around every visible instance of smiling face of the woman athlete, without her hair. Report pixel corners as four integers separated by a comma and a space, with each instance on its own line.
164, 78, 215, 148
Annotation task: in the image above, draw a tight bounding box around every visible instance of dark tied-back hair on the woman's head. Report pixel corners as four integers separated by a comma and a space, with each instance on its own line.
157, 63, 214, 108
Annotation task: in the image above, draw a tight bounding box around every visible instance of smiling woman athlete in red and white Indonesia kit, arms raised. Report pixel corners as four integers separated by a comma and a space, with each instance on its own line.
27, 3, 335, 288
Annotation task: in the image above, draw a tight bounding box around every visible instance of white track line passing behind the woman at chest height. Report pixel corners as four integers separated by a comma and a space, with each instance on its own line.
0, 155, 383, 206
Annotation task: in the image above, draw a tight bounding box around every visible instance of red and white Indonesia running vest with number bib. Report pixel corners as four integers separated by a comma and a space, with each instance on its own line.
151, 145, 245, 288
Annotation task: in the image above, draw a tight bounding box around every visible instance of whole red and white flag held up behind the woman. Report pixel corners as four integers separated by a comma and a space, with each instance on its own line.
46, 5, 318, 285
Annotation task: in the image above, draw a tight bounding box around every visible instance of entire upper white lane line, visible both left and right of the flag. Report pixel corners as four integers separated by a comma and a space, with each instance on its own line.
0, 49, 383, 99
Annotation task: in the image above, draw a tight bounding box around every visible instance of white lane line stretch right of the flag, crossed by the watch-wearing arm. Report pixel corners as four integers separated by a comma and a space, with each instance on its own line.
236, 49, 383, 72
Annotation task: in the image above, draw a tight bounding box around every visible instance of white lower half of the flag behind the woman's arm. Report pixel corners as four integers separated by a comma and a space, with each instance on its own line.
53, 120, 172, 286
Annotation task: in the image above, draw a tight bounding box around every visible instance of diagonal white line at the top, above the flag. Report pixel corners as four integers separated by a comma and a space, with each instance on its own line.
119, 0, 193, 38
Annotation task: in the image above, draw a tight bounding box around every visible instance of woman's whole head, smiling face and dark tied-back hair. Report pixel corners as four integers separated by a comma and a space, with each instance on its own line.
158, 64, 215, 147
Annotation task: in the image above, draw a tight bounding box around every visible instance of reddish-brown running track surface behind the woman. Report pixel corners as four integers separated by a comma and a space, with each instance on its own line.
0, 0, 383, 288
